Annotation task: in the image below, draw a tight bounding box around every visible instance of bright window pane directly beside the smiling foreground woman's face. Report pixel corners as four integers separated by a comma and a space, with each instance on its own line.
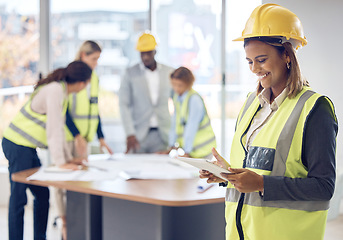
224, 0, 261, 156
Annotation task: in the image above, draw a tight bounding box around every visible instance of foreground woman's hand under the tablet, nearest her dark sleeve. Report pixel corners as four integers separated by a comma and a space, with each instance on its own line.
221, 168, 264, 193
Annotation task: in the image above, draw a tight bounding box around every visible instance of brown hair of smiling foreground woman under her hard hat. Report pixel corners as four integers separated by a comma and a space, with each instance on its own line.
244, 37, 310, 98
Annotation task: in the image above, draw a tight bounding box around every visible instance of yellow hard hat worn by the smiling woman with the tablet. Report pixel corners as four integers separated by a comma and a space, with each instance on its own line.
233, 3, 307, 49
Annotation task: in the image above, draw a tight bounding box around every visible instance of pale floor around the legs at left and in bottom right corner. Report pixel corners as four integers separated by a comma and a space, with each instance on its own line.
0, 200, 343, 240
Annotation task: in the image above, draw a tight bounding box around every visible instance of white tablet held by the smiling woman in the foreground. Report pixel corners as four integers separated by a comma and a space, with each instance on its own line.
176, 157, 231, 179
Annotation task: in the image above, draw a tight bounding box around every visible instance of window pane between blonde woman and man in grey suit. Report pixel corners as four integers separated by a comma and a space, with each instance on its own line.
51, 0, 149, 152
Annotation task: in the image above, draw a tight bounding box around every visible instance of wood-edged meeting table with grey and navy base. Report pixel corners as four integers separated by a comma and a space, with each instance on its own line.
12, 168, 225, 240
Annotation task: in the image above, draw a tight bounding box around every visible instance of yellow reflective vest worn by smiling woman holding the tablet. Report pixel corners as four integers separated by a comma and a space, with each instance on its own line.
225, 87, 337, 240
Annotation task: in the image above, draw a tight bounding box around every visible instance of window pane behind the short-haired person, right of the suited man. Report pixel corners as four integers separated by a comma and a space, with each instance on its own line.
152, 0, 221, 148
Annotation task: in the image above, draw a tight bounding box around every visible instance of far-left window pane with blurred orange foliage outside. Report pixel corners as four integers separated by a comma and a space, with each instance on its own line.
0, 0, 39, 164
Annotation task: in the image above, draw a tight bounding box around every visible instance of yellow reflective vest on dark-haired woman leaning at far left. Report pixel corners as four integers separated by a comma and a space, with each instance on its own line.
3, 81, 68, 148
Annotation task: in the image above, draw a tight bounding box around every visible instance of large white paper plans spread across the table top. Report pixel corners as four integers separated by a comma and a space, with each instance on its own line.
28, 154, 199, 181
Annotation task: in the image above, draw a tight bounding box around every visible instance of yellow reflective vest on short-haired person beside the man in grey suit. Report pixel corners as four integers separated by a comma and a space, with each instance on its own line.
173, 89, 217, 158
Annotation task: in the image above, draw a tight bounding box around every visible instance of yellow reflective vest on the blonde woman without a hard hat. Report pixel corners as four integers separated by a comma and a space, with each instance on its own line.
65, 71, 99, 142
